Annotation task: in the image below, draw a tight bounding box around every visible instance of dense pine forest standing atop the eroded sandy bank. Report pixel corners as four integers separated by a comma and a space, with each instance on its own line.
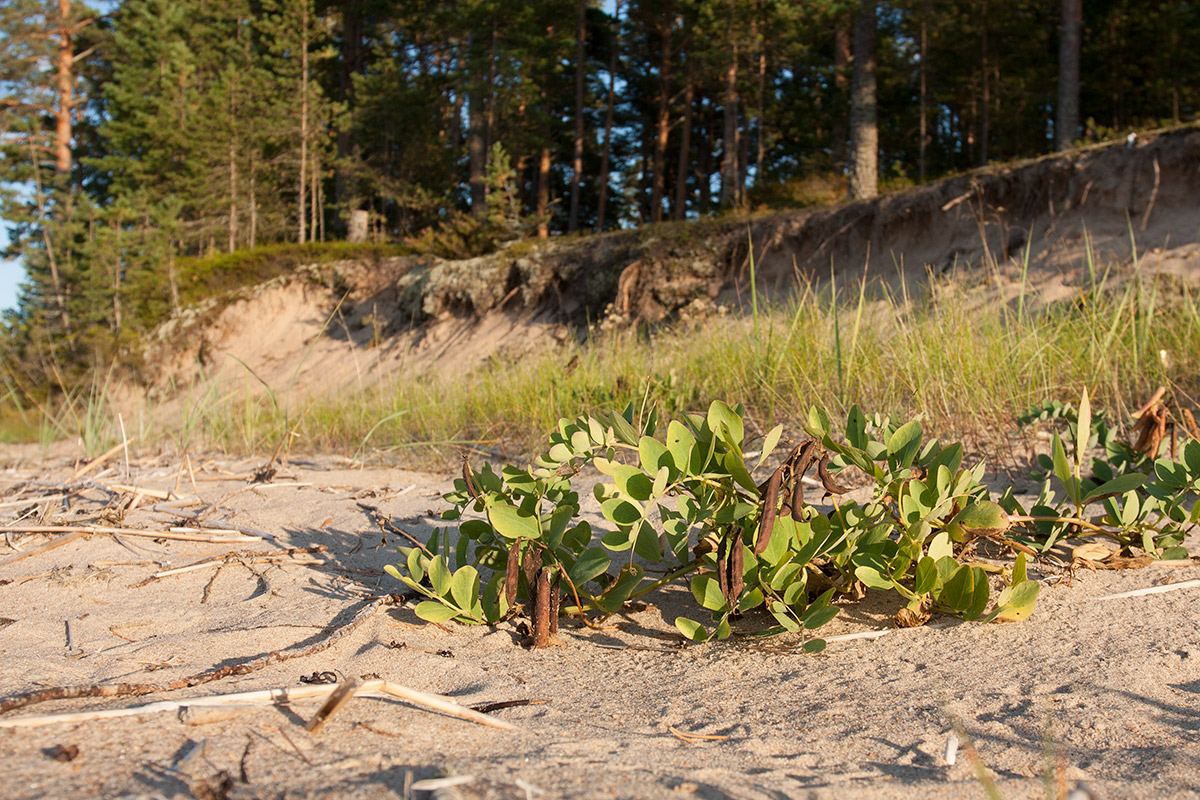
0, 0, 1200, 357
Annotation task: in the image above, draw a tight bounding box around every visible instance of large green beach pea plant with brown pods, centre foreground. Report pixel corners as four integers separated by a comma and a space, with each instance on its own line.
388, 401, 1056, 651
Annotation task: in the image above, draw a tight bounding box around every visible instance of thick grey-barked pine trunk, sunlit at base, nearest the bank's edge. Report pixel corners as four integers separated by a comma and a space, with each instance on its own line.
850, 0, 880, 200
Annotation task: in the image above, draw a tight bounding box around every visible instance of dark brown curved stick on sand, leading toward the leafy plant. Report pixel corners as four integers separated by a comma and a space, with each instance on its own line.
0, 595, 394, 714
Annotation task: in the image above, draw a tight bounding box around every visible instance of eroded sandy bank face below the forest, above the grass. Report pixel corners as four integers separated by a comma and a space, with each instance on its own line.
148, 128, 1200, 395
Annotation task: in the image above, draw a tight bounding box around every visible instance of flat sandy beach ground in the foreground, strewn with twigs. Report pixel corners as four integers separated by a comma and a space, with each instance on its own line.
0, 459, 1200, 800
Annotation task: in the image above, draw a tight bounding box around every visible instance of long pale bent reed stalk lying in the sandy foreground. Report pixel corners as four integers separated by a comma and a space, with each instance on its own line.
0, 680, 517, 730
